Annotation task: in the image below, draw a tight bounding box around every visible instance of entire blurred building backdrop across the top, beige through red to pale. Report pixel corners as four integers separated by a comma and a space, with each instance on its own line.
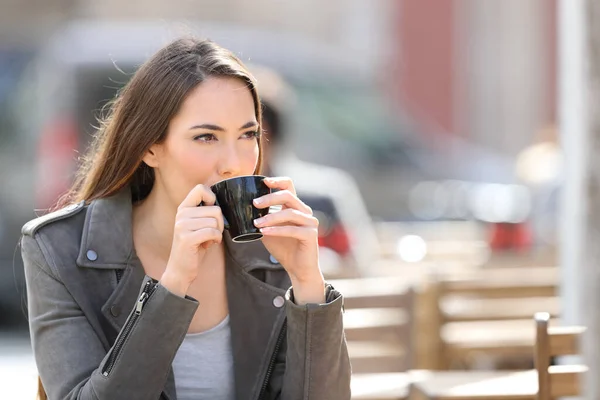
0, 0, 556, 156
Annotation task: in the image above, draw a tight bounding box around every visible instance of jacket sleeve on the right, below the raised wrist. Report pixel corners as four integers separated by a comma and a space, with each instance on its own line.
280, 285, 351, 400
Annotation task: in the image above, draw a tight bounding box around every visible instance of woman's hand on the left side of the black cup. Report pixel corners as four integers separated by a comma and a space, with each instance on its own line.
160, 185, 224, 297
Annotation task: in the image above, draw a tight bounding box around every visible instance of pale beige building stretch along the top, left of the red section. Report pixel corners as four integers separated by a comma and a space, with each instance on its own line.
0, 0, 395, 74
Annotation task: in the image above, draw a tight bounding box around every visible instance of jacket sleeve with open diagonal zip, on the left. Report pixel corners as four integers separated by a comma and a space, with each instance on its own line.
21, 235, 198, 400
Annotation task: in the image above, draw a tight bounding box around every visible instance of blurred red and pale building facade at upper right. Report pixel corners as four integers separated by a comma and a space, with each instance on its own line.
391, 0, 557, 157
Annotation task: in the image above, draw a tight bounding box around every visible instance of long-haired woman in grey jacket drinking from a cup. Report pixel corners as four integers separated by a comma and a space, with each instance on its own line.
21, 39, 350, 400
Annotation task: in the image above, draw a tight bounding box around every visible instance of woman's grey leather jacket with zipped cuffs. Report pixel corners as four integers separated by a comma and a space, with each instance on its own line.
21, 189, 350, 400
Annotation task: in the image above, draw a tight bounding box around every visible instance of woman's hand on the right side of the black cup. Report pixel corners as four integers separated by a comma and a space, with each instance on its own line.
254, 178, 325, 303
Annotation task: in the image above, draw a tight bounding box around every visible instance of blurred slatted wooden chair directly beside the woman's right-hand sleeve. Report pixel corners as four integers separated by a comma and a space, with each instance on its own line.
340, 277, 415, 400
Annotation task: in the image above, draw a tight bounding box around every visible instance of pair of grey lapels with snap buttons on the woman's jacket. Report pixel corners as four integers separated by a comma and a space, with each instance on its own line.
77, 187, 281, 272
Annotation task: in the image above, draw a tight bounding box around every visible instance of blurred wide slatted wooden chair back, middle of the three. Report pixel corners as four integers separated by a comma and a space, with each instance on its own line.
415, 267, 560, 370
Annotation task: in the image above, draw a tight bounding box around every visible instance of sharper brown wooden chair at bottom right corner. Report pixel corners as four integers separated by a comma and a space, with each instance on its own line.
534, 312, 587, 400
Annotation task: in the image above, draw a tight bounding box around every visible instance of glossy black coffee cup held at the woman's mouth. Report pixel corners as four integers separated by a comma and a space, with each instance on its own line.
210, 175, 271, 243
